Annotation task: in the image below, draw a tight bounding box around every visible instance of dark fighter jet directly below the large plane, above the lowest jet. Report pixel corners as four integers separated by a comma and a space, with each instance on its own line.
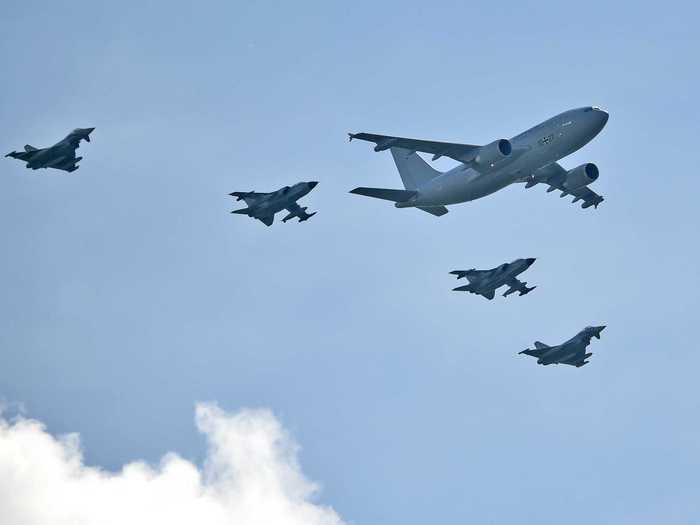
450, 258, 537, 301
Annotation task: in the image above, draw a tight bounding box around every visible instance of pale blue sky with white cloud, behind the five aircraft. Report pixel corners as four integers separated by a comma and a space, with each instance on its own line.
0, 0, 700, 525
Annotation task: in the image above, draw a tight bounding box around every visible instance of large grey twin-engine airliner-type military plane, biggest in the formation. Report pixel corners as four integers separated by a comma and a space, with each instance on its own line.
349, 106, 608, 217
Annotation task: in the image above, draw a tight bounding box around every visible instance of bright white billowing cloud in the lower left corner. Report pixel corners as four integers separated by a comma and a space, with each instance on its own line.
0, 404, 344, 525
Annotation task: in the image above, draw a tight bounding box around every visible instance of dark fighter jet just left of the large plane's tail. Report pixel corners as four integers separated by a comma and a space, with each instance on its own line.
229, 182, 318, 226
